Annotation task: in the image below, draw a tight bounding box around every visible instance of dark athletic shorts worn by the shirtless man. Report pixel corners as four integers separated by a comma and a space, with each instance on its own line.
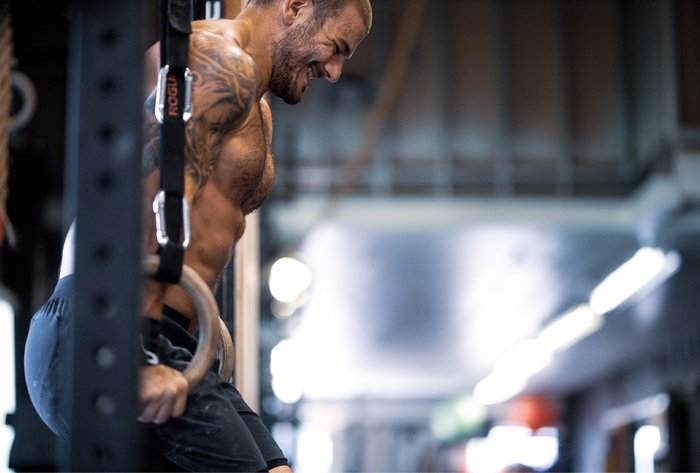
24, 275, 287, 471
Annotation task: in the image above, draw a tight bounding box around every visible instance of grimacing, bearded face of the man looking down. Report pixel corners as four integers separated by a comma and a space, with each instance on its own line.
270, 5, 365, 104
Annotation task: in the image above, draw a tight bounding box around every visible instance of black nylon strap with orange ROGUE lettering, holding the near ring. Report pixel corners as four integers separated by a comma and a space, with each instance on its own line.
154, 0, 193, 284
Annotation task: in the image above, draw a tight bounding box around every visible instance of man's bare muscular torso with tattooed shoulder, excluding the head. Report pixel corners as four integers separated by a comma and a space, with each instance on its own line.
166, 22, 274, 314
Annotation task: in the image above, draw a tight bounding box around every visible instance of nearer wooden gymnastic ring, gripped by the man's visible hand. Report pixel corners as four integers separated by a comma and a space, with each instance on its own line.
142, 255, 221, 390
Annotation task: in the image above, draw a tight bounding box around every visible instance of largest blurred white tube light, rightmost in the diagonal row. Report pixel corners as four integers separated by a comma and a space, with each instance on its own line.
590, 247, 680, 314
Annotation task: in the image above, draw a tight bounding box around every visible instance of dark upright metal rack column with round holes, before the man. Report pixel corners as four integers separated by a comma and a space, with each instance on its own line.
65, 0, 144, 471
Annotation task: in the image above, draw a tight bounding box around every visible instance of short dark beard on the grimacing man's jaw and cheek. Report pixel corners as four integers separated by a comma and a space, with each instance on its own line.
270, 19, 320, 104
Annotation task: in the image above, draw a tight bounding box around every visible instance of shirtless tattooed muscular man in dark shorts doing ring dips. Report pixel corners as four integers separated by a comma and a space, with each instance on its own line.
25, 0, 372, 471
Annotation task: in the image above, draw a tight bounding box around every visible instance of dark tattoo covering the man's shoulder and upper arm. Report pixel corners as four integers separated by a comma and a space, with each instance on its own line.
186, 32, 256, 193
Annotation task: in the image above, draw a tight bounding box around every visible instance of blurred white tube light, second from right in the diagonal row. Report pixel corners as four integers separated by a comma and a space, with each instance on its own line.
537, 304, 603, 352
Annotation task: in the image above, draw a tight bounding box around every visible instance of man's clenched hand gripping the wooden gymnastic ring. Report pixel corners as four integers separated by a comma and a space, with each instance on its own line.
138, 365, 189, 424
